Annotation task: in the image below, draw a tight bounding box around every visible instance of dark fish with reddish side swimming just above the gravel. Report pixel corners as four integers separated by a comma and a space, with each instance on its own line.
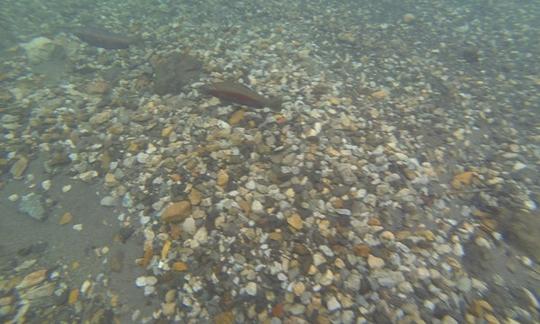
202, 81, 281, 109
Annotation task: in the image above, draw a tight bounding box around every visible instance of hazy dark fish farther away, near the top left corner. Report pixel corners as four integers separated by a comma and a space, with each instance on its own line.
72, 27, 136, 49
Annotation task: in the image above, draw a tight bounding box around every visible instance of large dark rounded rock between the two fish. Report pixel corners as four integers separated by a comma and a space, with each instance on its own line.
154, 53, 202, 95
